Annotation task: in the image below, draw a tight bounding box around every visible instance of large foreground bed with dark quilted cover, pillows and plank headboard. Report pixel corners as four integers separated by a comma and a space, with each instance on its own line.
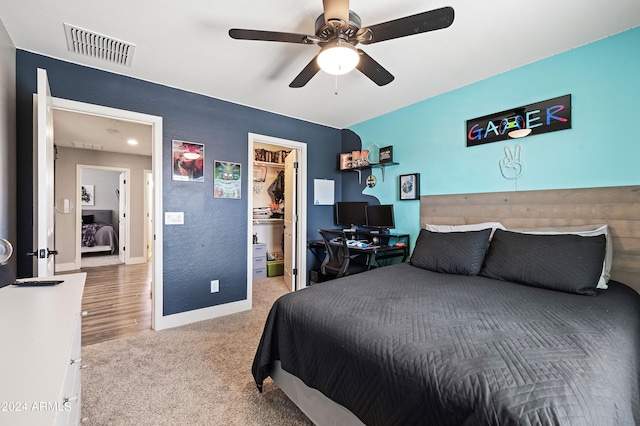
252, 187, 640, 425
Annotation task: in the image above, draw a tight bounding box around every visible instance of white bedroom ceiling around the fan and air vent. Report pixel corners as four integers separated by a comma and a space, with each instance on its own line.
0, 0, 640, 135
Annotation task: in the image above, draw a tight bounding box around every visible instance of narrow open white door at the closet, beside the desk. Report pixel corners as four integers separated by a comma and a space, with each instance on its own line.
284, 149, 298, 291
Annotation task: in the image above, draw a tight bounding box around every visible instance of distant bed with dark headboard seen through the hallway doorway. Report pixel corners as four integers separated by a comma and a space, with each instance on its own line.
80, 210, 119, 254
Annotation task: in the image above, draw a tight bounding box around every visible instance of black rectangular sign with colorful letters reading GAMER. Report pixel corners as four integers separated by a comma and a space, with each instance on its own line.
467, 95, 571, 146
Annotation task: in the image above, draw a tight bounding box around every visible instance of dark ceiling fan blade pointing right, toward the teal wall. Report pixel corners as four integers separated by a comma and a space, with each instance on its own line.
358, 6, 454, 44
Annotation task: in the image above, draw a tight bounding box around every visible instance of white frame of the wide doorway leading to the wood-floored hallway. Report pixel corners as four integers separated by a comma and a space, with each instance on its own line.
52, 97, 165, 330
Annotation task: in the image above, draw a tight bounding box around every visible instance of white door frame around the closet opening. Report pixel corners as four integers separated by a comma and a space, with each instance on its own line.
246, 133, 307, 306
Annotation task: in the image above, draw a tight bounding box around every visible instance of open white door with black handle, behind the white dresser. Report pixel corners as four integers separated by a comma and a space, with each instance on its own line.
31, 68, 56, 277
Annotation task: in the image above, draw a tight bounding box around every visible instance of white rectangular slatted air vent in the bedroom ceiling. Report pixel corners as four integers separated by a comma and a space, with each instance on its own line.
64, 24, 135, 67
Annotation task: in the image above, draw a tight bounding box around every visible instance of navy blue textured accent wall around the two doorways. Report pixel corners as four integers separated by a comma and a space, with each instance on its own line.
16, 50, 342, 315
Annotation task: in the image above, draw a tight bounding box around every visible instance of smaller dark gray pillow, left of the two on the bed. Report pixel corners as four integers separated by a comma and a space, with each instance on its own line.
411, 228, 491, 275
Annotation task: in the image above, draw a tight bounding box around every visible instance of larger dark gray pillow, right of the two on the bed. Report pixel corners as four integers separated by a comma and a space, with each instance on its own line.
480, 229, 606, 295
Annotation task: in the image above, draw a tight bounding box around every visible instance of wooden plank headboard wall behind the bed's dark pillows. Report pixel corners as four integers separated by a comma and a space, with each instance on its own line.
420, 186, 640, 292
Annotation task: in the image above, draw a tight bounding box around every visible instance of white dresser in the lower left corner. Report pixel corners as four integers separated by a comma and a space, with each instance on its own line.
0, 273, 86, 425
